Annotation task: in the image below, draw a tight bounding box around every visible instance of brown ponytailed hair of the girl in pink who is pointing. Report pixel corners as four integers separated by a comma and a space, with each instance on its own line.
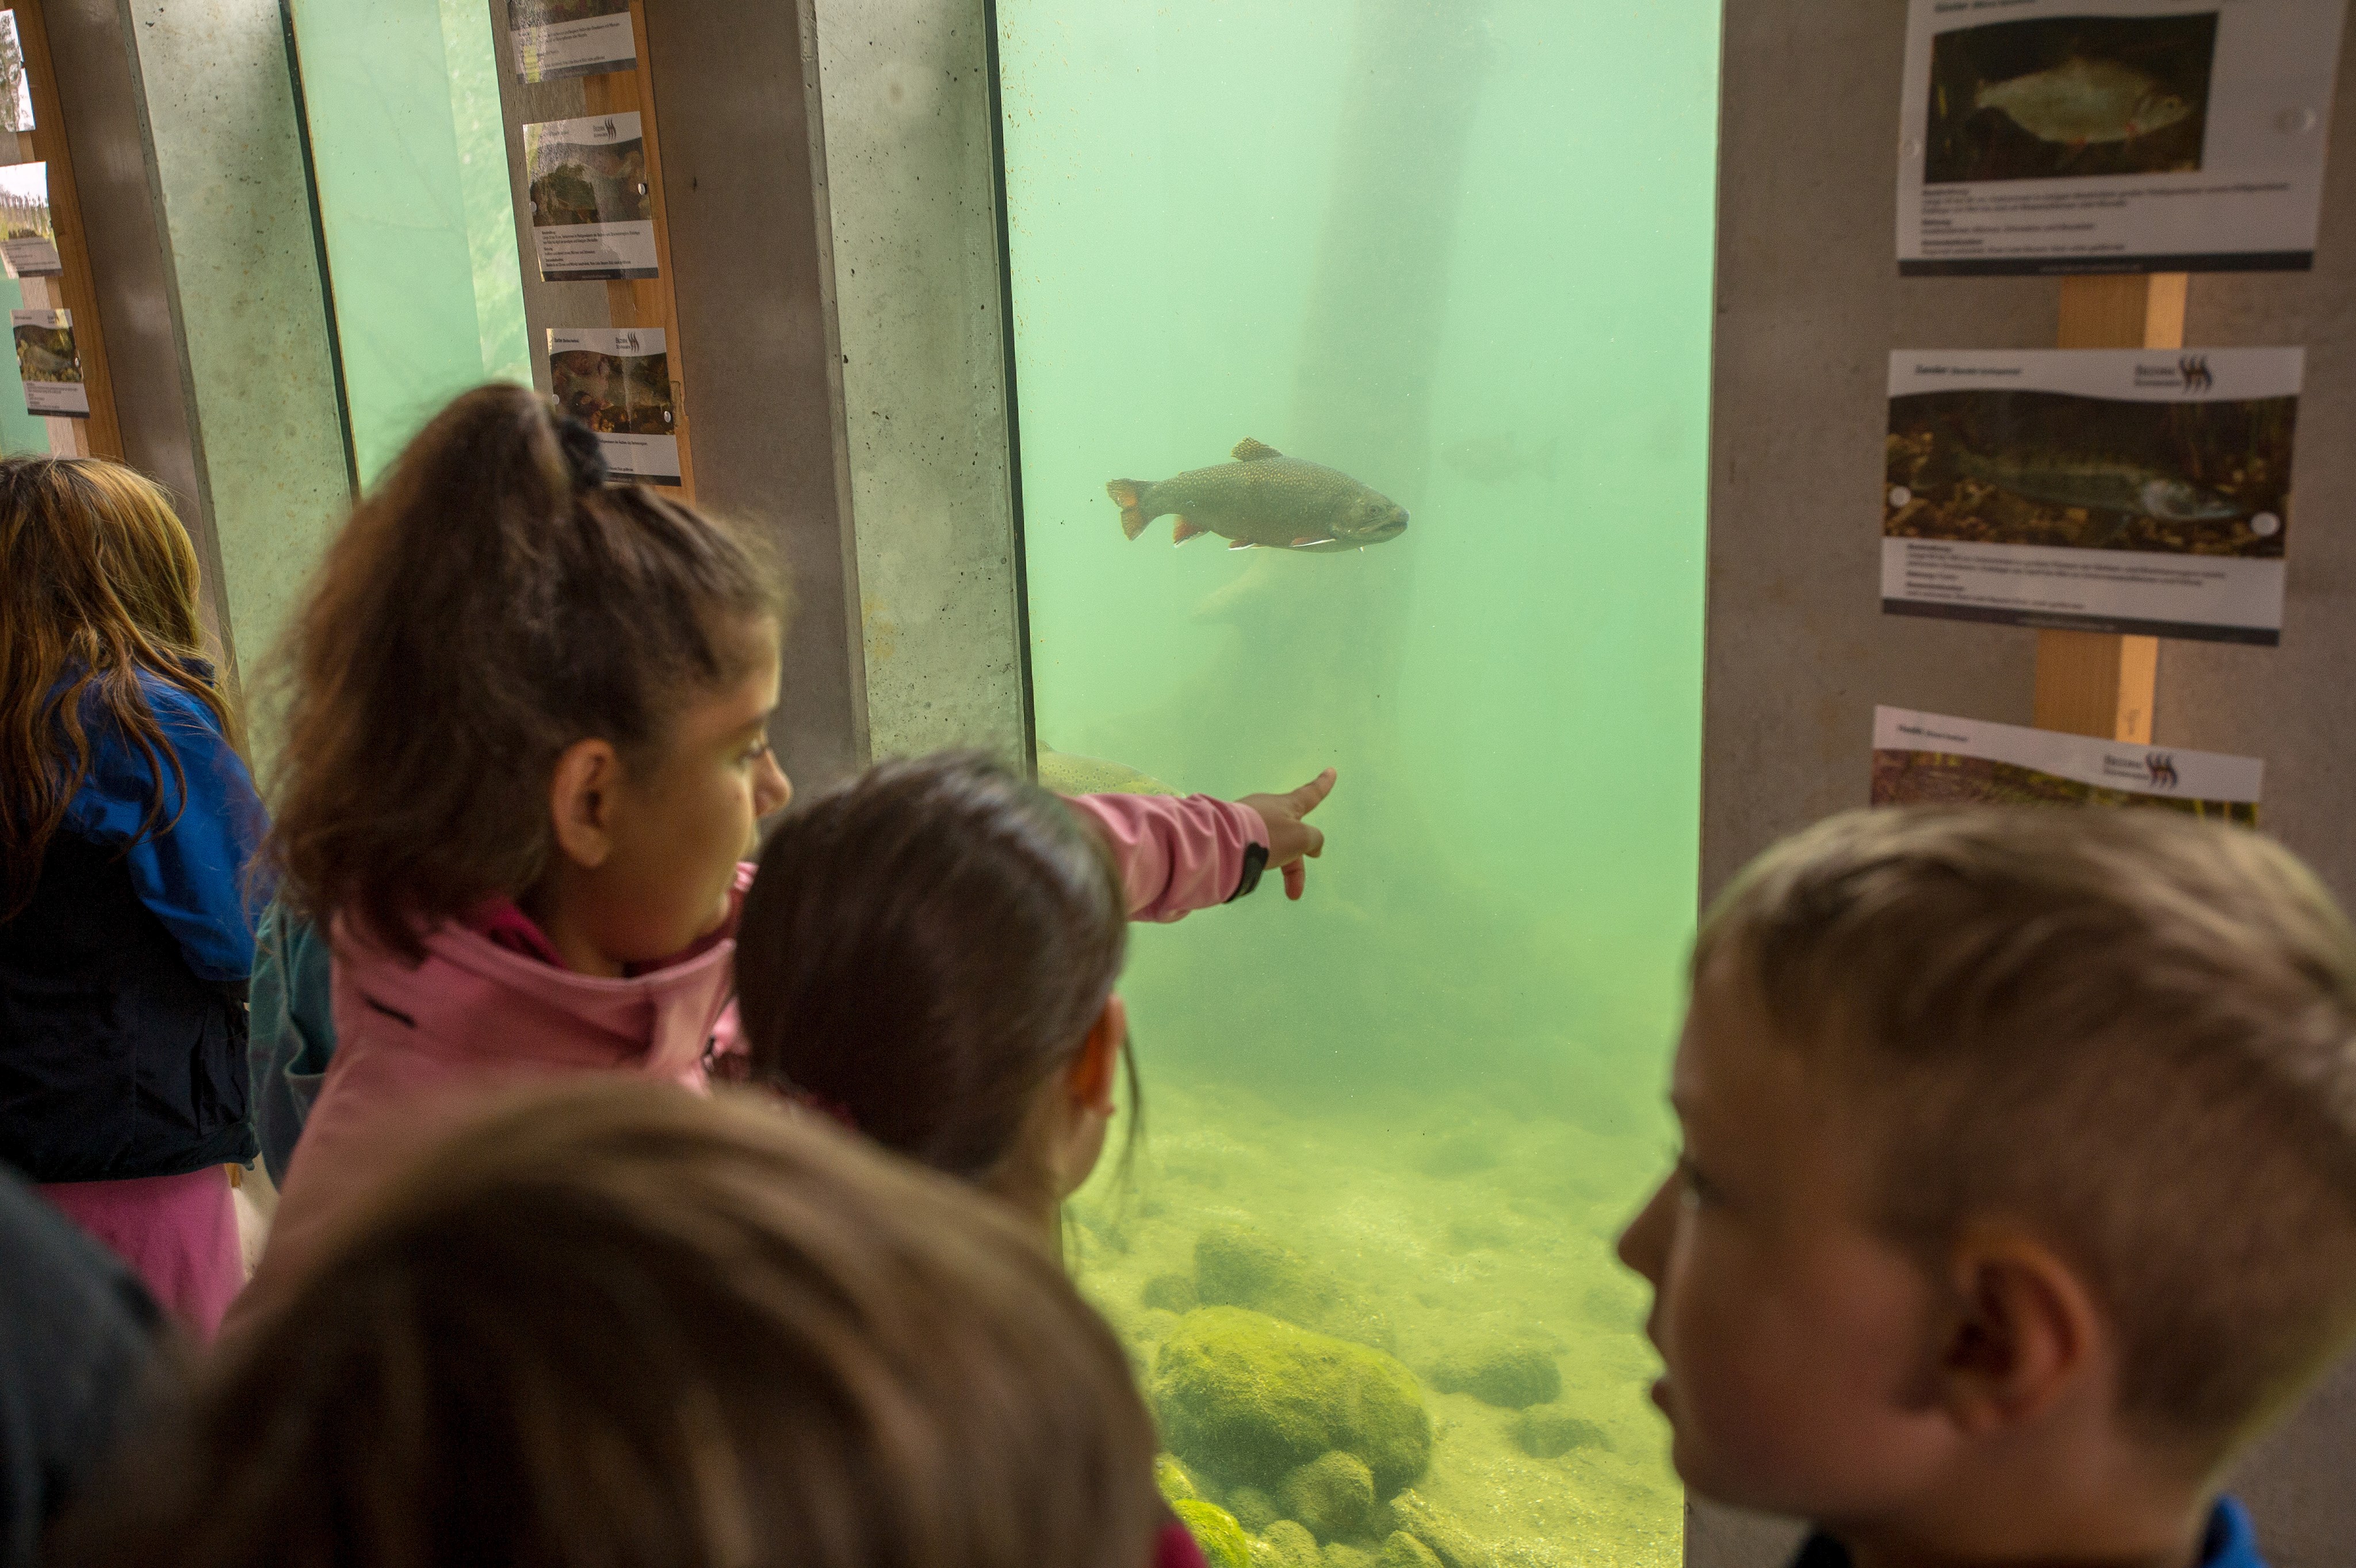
271, 386, 782, 958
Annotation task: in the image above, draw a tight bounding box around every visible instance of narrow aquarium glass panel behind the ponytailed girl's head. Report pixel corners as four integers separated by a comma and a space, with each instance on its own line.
292, 0, 533, 483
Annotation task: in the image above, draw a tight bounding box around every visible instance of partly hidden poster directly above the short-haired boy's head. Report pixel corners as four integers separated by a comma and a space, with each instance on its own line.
1873, 709, 2266, 827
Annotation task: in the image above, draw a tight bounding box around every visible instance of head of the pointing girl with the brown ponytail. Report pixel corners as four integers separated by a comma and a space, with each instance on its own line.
273, 386, 787, 972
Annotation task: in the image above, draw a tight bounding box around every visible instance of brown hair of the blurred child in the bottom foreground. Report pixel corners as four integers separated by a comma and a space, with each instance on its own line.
59, 1079, 1161, 1568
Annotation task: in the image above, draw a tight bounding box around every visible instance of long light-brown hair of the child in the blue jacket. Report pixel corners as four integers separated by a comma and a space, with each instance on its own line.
0, 457, 243, 918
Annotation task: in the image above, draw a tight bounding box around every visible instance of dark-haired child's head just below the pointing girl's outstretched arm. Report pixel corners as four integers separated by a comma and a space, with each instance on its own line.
737, 754, 1129, 1210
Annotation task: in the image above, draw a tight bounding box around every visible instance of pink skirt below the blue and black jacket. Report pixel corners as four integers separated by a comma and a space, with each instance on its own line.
40, 1165, 245, 1342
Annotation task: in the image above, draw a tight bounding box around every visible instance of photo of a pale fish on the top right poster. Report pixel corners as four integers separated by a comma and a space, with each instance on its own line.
1922, 12, 2217, 183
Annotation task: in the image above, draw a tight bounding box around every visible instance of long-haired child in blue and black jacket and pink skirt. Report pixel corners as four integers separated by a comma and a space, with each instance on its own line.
0, 457, 264, 1337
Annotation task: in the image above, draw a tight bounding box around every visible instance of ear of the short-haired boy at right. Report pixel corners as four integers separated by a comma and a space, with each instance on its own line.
1937, 1229, 2106, 1436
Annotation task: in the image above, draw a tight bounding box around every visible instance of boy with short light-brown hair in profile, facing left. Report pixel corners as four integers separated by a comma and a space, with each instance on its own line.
1619, 808, 2356, 1568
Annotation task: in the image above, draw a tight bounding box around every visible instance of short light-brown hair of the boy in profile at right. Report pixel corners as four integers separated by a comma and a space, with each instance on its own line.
1694, 808, 2356, 1452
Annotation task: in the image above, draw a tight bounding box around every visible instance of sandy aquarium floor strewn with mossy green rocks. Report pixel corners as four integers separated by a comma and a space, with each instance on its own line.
1065, 1071, 1682, 1568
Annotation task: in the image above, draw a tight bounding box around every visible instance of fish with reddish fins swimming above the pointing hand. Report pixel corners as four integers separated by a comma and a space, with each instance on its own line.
1105, 435, 1406, 553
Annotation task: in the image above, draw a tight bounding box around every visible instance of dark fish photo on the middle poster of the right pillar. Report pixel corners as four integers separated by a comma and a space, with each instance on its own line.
1883, 391, 2300, 558
